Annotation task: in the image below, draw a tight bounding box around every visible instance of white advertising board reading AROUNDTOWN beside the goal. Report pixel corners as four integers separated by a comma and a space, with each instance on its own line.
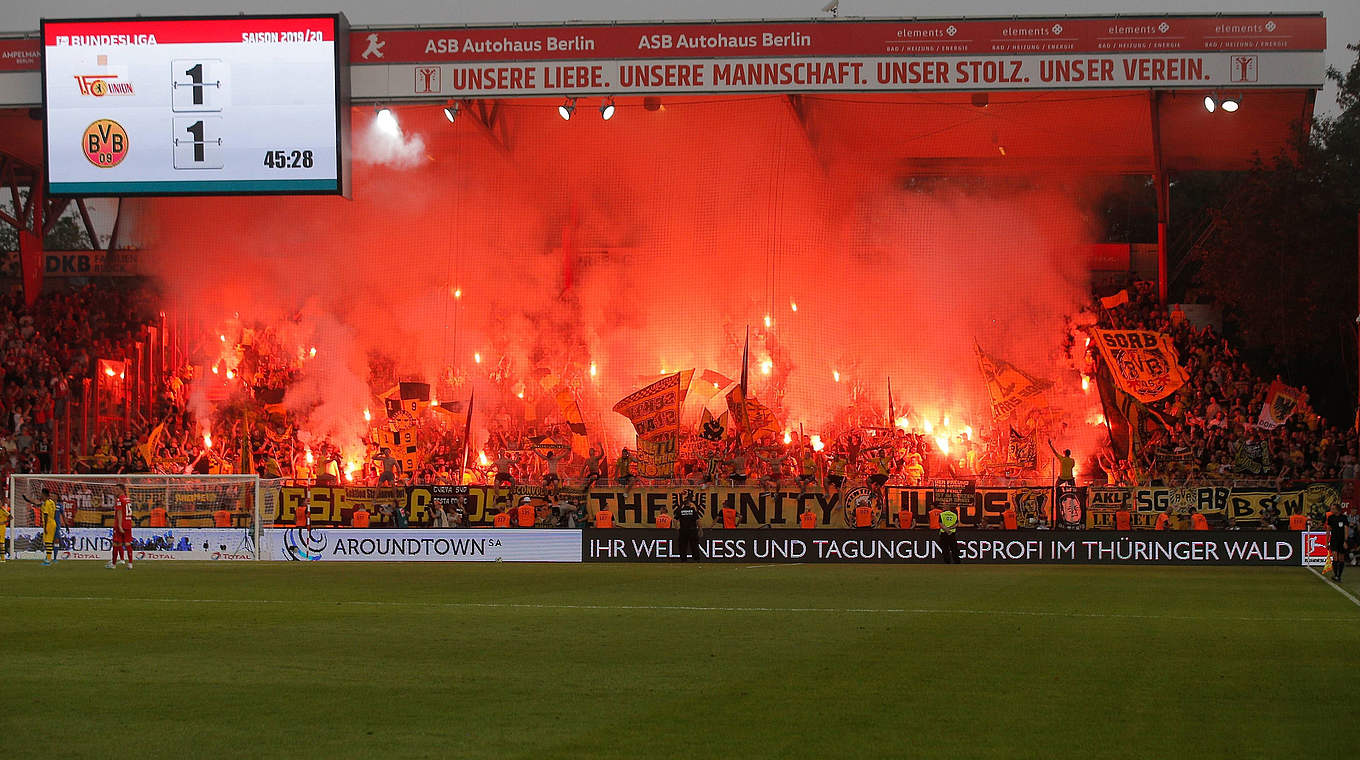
260, 528, 581, 563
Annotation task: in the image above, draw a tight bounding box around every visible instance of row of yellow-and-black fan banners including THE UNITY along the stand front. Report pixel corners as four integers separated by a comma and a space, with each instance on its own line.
259, 481, 1342, 529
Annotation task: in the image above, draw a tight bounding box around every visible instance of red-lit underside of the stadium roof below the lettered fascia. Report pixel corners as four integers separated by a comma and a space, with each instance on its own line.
0, 90, 1315, 175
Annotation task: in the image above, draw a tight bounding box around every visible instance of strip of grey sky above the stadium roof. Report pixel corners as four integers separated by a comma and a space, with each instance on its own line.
0, 0, 1360, 113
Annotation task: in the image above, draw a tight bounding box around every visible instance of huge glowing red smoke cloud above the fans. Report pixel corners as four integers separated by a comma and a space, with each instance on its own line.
125, 97, 1096, 456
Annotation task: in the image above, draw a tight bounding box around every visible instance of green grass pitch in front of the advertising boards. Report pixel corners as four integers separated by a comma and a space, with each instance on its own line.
0, 562, 1360, 760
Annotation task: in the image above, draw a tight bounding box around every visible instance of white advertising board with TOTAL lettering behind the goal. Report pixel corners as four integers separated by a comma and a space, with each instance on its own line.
11, 528, 256, 562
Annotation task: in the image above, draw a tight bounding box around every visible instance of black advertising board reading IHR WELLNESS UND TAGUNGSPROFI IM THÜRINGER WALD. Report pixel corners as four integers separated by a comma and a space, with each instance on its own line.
581, 529, 1304, 567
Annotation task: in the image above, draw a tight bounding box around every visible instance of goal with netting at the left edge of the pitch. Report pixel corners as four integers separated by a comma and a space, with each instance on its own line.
10, 474, 263, 559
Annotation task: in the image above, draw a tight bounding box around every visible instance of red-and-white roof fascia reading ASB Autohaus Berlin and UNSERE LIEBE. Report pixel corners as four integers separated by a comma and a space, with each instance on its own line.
350, 15, 1326, 99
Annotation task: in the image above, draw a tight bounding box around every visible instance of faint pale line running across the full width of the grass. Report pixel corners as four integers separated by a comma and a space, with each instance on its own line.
0, 591, 1360, 623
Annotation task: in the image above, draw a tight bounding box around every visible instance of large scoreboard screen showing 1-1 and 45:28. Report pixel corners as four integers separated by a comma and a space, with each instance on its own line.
42, 15, 348, 196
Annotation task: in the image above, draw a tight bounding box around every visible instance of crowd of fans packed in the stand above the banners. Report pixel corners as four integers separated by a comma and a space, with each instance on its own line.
0, 280, 1357, 505
